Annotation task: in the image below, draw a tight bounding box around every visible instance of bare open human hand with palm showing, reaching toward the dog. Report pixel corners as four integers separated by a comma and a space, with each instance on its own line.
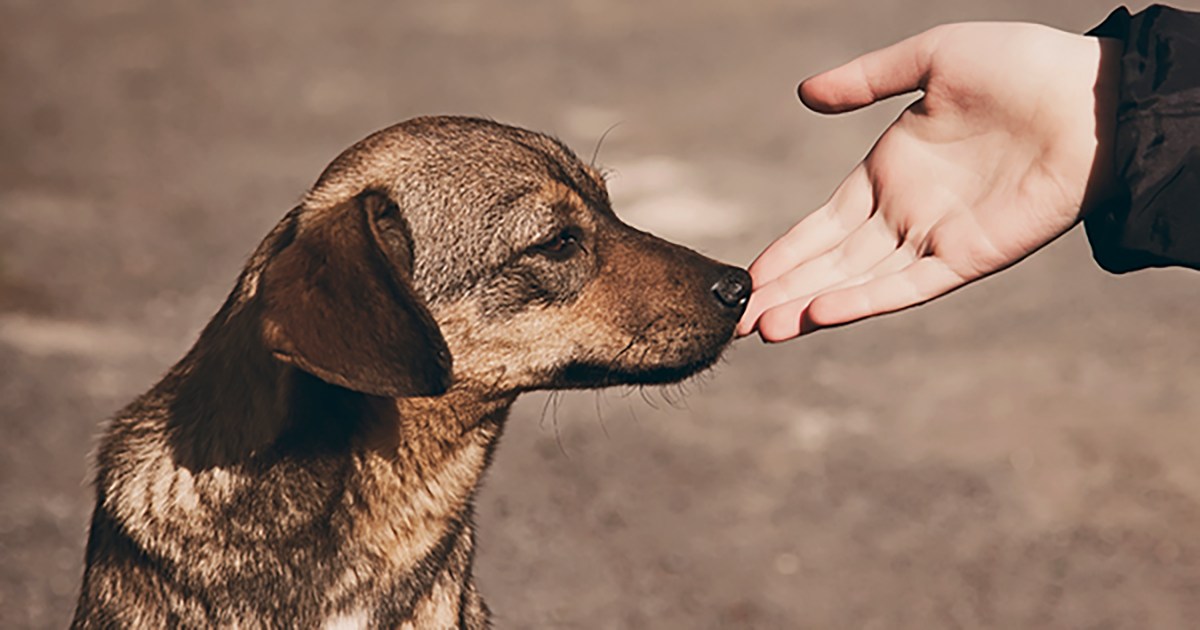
738, 23, 1120, 342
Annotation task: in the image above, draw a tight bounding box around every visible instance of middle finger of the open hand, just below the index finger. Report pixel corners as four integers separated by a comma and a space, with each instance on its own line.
738, 212, 912, 335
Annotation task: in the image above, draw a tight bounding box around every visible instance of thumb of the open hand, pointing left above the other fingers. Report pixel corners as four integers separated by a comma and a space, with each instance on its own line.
798, 29, 937, 114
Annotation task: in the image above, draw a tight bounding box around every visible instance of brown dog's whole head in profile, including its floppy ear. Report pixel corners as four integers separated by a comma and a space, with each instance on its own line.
240, 118, 750, 397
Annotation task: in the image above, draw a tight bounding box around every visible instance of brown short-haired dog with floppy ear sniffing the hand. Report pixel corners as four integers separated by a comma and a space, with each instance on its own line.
73, 116, 750, 629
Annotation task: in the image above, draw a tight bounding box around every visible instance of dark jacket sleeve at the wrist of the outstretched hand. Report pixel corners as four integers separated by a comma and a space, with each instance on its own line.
1084, 5, 1200, 274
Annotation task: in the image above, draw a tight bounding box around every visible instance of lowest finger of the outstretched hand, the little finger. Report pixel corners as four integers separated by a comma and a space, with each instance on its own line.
805, 256, 966, 328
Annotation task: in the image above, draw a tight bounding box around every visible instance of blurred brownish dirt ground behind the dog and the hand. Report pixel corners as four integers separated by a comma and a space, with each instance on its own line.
0, 0, 1200, 630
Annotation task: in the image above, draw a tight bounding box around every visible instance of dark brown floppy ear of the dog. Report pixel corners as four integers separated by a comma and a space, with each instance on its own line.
259, 192, 451, 397
